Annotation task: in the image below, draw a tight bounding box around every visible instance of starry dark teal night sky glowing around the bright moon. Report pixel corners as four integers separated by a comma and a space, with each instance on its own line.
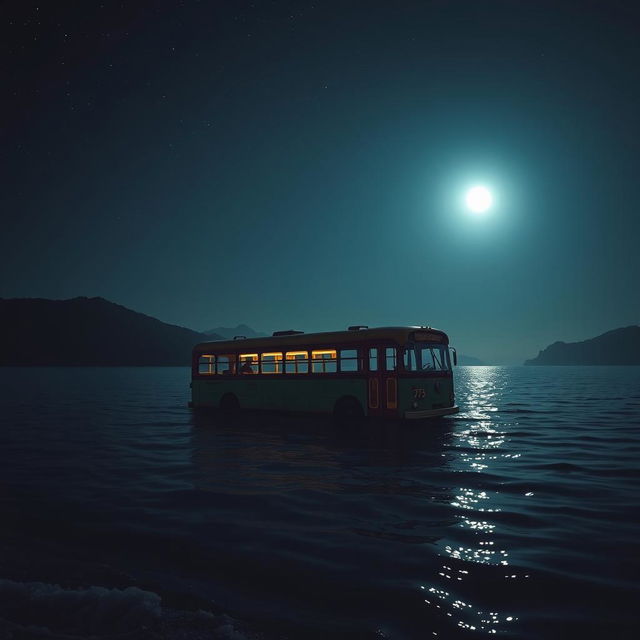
5, 0, 640, 363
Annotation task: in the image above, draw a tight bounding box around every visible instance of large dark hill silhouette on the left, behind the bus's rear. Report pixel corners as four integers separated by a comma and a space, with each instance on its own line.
0, 297, 219, 366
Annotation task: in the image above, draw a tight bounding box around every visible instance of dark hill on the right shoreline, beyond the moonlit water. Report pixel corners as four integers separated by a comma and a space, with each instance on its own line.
525, 325, 640, 365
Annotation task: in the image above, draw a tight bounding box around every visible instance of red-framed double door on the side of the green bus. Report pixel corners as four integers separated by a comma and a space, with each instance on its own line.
367, 346, 398, 417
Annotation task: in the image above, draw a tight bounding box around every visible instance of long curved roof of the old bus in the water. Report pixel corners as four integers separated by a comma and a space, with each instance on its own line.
193, 327, 449, 353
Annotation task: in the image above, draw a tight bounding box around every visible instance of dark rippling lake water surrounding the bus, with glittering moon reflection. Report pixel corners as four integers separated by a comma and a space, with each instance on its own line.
0, 367, 640, 640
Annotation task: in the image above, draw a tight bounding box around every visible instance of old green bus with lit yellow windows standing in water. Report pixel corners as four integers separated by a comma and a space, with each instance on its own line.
190, 326, 458, 419
